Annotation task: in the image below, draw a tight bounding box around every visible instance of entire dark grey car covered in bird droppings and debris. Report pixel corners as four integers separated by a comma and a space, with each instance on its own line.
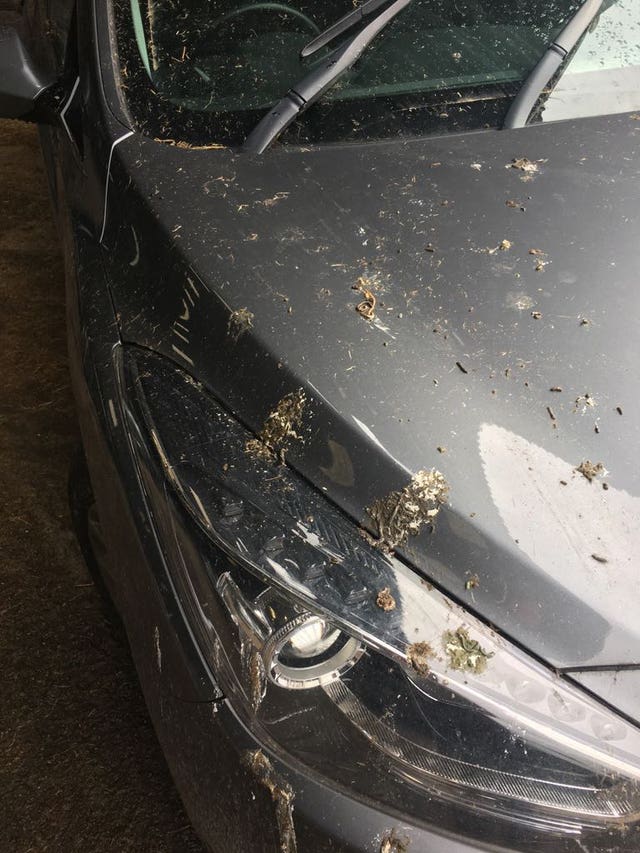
0, 0, 640, 853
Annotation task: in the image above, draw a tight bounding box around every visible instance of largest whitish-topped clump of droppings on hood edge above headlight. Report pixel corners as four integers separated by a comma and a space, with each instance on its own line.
367, 469, 449, 551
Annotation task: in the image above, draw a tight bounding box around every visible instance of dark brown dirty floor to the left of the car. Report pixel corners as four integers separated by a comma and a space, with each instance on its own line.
0, 122, 202, 853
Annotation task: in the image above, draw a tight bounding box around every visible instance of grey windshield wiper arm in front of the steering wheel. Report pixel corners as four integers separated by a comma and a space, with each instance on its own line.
242, 0, 413, 154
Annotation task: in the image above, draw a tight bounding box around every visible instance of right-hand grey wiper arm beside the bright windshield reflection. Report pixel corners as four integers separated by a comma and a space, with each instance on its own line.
503, 0, 602, 129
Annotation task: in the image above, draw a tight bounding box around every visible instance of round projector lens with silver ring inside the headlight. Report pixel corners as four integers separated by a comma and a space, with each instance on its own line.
263, 613, 364, 690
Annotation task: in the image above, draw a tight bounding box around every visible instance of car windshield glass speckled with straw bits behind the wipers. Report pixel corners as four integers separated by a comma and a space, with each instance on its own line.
116, 0, 640, 145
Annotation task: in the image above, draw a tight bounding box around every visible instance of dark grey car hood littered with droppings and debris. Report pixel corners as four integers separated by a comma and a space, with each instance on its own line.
104, 116, 640, 670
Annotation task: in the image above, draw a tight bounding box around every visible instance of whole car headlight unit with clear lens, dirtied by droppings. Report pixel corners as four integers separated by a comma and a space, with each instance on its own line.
121, 348, 640, 849
